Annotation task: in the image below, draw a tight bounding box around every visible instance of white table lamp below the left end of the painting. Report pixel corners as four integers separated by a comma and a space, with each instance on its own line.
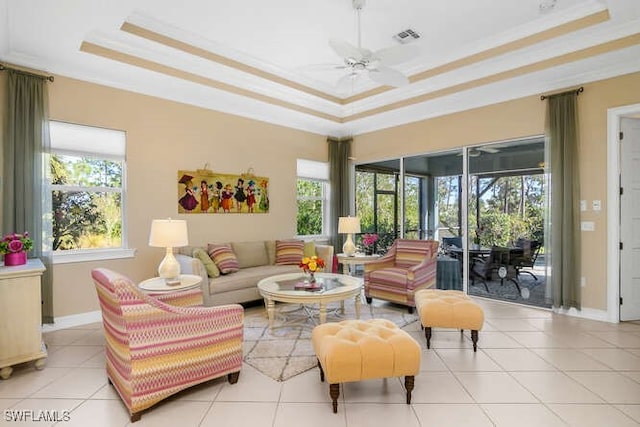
149, 218, 189, 280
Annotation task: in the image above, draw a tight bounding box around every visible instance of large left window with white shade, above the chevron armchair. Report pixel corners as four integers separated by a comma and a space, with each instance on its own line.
45, 121, 132, 262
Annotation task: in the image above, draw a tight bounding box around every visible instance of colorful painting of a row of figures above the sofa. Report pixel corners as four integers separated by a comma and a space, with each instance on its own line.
177, 169, 269, 214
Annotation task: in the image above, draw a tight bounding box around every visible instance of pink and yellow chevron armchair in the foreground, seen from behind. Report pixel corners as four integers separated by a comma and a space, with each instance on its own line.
91, 268, 244, 422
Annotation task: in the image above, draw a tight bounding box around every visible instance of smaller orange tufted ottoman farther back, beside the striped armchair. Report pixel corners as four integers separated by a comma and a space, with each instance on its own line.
415, 289, 484, 351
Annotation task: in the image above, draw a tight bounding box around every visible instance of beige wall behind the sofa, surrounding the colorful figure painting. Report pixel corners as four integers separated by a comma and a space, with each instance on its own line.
0, 76, 327, 317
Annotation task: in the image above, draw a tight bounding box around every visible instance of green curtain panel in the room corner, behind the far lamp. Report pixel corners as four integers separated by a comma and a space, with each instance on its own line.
327, 138, 353, 253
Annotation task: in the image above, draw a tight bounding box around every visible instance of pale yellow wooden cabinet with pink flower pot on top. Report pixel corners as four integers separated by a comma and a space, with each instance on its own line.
0, 259, 47, 380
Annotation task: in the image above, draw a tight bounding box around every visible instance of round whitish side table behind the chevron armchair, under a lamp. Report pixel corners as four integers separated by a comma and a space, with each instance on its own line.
138, 274, 204, 307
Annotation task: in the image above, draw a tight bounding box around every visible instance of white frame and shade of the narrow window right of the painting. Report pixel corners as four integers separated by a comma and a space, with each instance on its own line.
296, 159, 330, 240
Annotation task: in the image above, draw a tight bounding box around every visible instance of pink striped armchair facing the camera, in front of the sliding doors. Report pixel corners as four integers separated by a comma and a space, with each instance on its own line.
364, 239, 438, 313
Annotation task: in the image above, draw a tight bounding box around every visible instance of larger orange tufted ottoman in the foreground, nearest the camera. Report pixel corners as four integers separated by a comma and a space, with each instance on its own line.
311, 319, 420, 413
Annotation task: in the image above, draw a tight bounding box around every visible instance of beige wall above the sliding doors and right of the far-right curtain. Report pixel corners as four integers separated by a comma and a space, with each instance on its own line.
353, 73, 640, 310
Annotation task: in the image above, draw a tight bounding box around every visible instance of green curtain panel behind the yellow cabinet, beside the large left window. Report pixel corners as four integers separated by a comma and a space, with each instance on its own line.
2, 69, 53, 323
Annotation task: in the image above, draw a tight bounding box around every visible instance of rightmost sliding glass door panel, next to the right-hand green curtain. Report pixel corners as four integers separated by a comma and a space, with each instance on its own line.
467, 138, 551, 307
